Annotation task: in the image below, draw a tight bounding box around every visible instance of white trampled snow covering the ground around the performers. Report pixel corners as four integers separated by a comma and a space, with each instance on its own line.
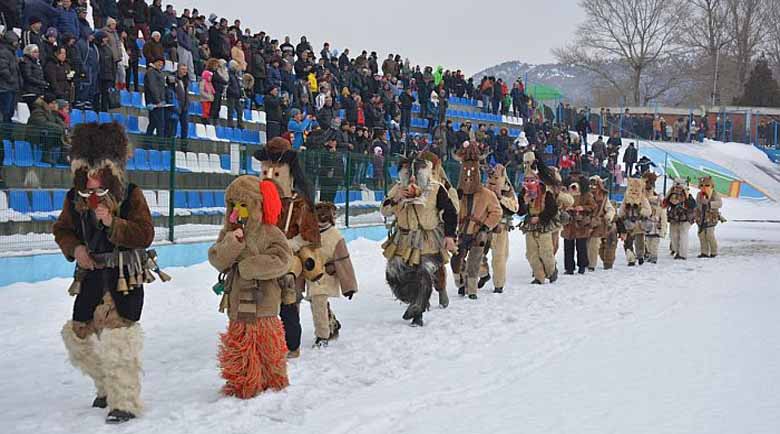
0, 200, 780, 434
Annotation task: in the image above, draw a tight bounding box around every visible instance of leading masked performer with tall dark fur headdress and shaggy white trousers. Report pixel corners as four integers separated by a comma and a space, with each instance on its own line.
53, 123, 156, 424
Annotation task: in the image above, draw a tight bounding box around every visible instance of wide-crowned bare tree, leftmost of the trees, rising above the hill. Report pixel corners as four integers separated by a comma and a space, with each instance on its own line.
553, 0, 687, 105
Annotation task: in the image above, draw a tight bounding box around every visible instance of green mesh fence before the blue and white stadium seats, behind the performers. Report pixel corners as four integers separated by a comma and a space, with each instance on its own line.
0, 120, 444, 255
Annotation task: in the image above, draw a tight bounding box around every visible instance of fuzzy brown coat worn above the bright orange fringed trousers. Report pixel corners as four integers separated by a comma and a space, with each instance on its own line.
209, 222, 292, 321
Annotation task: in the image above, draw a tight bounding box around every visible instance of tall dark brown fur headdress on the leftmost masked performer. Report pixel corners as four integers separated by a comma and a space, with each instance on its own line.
70, 122, 130, 201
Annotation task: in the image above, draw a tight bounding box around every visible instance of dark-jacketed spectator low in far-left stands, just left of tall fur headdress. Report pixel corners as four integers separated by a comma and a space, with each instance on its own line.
25, 93, 65, 163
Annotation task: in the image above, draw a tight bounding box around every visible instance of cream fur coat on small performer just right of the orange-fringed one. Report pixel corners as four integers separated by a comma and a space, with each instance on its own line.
306, 226, 358, 300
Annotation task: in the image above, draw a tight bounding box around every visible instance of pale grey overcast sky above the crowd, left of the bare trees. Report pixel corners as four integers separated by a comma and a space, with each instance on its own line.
172, 0, 584, 75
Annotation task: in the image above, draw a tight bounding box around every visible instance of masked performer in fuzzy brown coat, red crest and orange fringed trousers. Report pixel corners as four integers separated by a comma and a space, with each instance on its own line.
209, 176, 293, 399
